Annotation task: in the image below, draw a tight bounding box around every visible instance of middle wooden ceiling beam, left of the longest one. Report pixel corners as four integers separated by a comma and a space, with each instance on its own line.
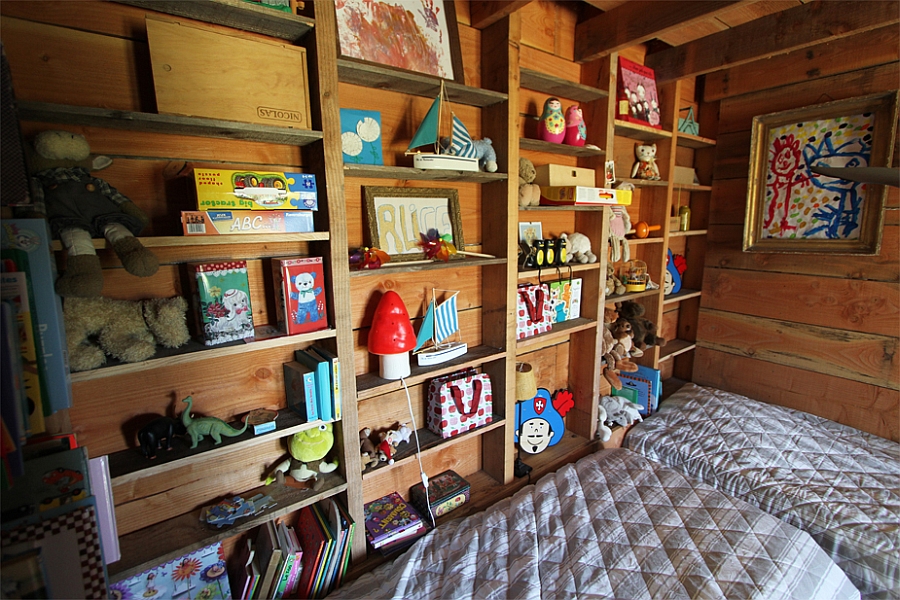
575, 0, 750, 62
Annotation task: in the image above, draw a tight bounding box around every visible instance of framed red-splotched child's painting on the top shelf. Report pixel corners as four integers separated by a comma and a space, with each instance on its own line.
335, 0, 465, 83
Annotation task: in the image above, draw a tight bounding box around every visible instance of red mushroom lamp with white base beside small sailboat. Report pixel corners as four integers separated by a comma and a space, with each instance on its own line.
369, 291, 416, 379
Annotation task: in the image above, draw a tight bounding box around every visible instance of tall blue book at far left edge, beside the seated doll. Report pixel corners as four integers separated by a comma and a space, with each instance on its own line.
0, 219, 72, 412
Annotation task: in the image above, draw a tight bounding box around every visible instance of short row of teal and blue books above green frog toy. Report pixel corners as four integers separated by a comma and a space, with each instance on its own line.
284, 346, 342, 421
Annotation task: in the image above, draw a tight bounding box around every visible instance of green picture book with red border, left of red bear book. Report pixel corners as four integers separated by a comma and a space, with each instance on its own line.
188, 260, 254, 346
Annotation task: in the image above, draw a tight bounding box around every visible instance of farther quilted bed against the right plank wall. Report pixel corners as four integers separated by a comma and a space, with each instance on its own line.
623, 384, 900, 598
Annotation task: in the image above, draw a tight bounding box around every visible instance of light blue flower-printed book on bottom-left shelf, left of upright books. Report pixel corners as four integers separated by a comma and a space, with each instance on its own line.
110, 542, 231, 600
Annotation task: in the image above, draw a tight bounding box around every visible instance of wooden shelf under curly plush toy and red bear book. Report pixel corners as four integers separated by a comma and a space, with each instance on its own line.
72, 329, 335, 383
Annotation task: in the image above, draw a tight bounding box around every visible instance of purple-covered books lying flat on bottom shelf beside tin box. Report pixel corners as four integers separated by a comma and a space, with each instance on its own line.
365, 492, 427, 554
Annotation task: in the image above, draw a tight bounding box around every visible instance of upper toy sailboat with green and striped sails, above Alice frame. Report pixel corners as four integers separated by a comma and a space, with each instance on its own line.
406, 80, 479, 171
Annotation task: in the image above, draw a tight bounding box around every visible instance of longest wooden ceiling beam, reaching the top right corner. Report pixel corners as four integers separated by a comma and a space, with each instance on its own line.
644, 0, 900, 83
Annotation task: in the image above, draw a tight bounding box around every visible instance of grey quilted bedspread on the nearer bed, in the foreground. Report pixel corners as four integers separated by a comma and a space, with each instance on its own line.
330, 449, 859, 600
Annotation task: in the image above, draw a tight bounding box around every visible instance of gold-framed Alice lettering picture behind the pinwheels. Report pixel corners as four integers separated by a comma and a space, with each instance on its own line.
363, 186, 465, 261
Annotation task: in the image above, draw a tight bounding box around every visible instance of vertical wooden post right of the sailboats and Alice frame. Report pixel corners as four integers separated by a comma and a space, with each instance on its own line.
481, 13, 521, 484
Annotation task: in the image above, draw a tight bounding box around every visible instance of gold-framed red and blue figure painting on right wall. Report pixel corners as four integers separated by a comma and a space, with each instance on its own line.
743, 91, 898, 255
